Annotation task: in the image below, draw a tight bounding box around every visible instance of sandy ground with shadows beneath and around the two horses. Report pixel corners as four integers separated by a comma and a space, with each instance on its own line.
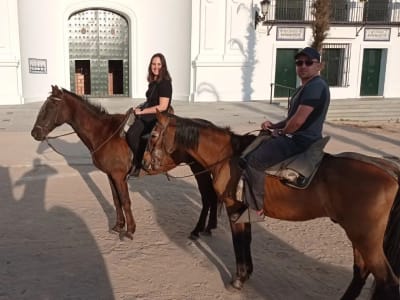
0, 101, 400, 300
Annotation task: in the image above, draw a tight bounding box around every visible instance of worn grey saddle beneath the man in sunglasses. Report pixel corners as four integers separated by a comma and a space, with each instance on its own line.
264, 136, 330, 189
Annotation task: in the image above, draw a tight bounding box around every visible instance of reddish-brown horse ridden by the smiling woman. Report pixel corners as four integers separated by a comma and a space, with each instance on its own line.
31, 86, 217, 239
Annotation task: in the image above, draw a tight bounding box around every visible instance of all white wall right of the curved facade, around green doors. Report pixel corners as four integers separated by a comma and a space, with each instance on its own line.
190, 0, 400, 101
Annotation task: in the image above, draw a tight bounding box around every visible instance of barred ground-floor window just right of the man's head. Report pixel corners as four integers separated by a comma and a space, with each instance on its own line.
321, 44, 350, 87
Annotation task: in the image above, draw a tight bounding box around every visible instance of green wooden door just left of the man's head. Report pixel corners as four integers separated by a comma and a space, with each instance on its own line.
274, 49, 298, 98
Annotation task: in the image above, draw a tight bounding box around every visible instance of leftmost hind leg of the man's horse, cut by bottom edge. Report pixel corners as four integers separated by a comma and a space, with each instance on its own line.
341, 245, 370, 300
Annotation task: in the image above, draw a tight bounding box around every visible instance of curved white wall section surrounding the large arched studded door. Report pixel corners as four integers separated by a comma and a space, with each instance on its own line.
15, 0, 191, 102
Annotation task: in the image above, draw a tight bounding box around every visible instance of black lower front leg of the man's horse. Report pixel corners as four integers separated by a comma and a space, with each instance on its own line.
228, 210, 253, 289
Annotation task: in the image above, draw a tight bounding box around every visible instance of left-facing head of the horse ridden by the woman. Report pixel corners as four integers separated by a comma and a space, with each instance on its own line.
31, 86, 69, 141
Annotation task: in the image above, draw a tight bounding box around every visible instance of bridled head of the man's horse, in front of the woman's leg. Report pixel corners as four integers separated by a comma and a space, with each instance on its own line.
142, 111, 177, 173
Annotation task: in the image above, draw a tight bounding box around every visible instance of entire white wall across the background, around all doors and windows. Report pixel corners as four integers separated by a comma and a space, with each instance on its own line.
0, 0, 400, 104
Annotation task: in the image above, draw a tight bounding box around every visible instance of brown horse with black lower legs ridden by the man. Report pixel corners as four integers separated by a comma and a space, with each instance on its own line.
144, 112, 400, 300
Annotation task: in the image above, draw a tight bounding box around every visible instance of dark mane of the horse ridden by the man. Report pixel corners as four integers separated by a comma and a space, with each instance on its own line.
170, 115, 255, 153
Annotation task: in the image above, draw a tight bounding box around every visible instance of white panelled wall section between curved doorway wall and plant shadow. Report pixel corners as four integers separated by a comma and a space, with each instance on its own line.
191, 0, 256, 101
